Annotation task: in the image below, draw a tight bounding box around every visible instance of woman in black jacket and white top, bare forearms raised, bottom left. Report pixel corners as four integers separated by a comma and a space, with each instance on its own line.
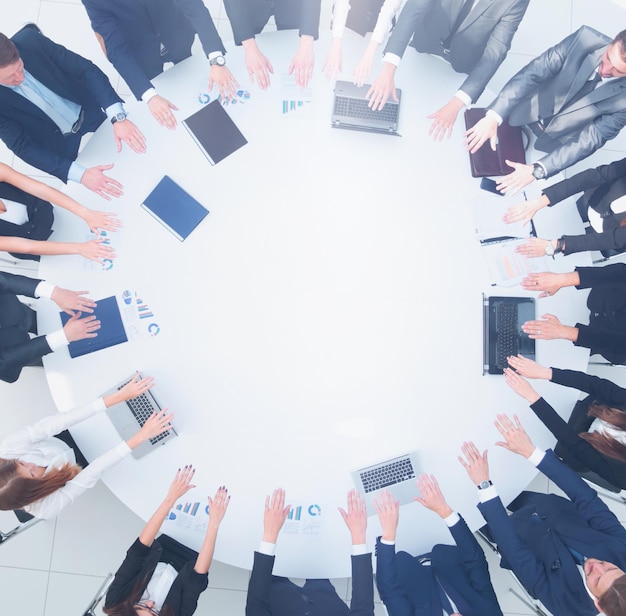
102, 466, 230, 616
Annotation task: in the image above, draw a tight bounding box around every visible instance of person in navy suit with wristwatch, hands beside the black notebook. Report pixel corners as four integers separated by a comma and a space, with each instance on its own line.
82, 0, 238, 128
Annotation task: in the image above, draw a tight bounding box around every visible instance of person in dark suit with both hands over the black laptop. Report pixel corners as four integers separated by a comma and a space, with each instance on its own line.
522, 263, 626, 364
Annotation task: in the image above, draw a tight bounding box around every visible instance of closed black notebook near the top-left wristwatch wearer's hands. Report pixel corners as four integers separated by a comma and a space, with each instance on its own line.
183, 101, 248, 165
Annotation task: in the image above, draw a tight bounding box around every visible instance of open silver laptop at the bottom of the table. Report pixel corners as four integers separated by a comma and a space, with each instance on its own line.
352, 451, 421, 515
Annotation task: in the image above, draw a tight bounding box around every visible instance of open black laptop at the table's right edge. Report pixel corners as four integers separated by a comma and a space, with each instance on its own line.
483, 295, 535, 374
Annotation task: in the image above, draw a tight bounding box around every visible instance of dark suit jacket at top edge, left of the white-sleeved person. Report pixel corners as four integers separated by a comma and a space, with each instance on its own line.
224, 0, 321, 45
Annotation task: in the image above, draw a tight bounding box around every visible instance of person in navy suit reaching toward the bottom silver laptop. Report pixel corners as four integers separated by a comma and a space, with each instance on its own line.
374, 475, 502, 616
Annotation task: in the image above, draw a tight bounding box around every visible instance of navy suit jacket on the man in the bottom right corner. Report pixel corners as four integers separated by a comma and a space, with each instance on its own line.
478, 450, 626, 616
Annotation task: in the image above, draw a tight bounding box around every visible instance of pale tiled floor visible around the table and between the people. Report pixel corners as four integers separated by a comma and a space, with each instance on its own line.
0, 0, 626, 616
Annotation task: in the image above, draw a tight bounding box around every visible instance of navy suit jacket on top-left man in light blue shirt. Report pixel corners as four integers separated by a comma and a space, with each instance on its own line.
0, 28, 122, 182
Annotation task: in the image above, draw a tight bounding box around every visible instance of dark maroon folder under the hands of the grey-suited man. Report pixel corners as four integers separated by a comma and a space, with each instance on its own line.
465, 107, 526, 178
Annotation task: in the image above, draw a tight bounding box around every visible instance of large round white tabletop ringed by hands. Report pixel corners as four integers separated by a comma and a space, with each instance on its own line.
39, 27, 589, 577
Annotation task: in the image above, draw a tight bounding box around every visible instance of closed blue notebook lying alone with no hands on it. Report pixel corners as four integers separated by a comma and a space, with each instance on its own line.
141, 175, 209, 242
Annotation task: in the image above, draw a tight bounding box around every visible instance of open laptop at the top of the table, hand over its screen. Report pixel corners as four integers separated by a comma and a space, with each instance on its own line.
331, 80, 402, 136
